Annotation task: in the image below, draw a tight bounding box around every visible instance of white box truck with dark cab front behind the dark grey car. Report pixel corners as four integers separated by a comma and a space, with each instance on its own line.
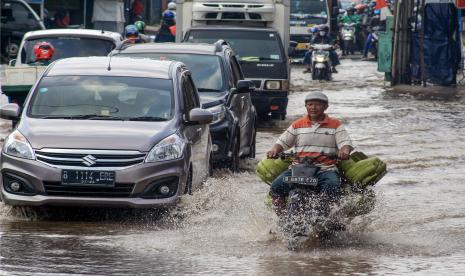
176, 0, 290, 119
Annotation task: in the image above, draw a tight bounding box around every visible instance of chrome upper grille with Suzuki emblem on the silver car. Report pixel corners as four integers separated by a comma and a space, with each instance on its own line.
35, 149, 146, 168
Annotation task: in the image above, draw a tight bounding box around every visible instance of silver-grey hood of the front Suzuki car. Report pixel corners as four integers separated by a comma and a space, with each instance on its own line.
18, 118, 176, 152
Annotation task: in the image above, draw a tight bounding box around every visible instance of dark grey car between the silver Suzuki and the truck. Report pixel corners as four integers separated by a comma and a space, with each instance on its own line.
112, 40, 257, 171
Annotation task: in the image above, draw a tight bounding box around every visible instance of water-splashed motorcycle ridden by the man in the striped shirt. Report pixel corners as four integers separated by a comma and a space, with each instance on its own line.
272, 153, 375, 251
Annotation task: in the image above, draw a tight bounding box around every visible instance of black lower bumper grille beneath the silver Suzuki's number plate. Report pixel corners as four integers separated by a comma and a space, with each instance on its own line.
44, 182, 134, 198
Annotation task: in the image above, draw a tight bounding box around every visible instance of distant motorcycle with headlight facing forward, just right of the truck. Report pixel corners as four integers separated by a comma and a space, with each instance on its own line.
310, 44, 333, 81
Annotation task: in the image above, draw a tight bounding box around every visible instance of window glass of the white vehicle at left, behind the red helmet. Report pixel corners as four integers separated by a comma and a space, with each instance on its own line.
21, 36, 115, 64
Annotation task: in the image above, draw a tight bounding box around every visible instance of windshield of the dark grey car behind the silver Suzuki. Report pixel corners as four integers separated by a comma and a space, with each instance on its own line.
119, 53, 225, 92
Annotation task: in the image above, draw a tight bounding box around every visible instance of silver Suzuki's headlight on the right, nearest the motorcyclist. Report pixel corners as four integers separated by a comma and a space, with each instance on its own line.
145, 133, 185, 162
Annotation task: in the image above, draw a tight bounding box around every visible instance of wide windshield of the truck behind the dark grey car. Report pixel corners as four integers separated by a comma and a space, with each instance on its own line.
187, 30, 284, 62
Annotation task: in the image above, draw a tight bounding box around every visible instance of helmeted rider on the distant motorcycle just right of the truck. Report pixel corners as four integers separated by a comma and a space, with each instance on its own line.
303, 25, 340, 73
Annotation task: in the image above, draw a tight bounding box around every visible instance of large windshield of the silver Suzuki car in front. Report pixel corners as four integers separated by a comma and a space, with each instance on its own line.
28, 76, 174, 121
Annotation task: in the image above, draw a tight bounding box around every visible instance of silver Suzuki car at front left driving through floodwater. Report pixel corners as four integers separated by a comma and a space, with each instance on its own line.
0, 57, 213, 208
